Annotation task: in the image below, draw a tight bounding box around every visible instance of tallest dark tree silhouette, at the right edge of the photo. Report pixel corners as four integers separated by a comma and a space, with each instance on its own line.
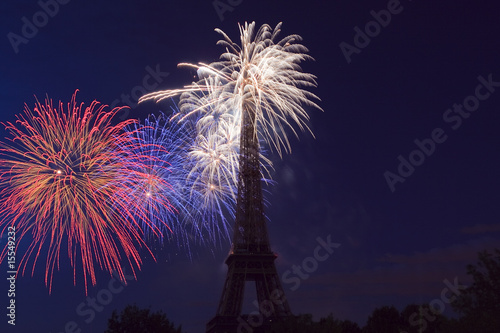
451, 249, 500, 333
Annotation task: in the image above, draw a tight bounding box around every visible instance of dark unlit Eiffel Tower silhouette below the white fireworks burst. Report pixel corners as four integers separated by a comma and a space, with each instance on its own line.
206, 102, 292, 333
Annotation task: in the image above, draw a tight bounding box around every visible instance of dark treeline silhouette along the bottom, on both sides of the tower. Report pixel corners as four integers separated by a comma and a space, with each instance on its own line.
105, 249, 500, 333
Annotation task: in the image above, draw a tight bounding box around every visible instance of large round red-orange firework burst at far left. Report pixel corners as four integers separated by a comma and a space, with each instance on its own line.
0, 92, 161, 291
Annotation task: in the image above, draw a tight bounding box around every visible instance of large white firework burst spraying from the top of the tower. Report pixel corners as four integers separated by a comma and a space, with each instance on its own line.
139, 22, 321, 155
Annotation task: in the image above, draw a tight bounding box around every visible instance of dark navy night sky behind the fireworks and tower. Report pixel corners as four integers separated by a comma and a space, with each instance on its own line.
0, 0, 500, 333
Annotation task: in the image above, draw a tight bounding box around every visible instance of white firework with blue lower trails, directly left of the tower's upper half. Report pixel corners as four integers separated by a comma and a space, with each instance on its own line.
177, 78, 264, 243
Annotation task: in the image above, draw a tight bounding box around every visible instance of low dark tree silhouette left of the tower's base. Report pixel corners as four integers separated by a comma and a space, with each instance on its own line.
104, 305, 182, 333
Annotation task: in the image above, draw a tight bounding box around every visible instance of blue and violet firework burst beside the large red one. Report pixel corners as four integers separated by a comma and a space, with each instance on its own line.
117, 113, 200, 246
